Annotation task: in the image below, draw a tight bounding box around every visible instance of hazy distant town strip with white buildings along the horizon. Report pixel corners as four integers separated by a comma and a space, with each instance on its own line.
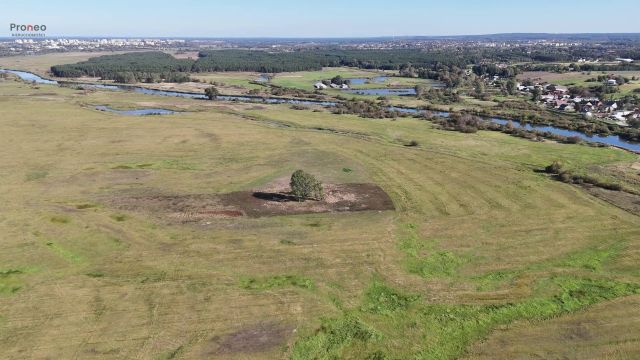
5, 34, 640, 55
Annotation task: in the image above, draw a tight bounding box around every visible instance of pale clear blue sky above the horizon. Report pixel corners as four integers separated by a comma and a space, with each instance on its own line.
0, 0, 640, 38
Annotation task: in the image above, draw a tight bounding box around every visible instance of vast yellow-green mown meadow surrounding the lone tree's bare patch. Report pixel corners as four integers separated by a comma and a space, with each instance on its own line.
0, 70, 640, 359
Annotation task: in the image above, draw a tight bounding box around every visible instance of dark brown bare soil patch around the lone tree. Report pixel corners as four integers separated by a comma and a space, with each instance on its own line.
106, 182, 395, 223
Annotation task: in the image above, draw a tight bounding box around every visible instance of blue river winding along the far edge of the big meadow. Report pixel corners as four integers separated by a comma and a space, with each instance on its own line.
0, 69, 640, 153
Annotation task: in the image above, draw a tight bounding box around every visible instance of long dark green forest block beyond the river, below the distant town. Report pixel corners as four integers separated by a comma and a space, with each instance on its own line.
51, 49, 521, 82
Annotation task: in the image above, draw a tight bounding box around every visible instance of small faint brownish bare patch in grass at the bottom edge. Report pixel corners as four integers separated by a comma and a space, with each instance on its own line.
203, 322, 292, 358
